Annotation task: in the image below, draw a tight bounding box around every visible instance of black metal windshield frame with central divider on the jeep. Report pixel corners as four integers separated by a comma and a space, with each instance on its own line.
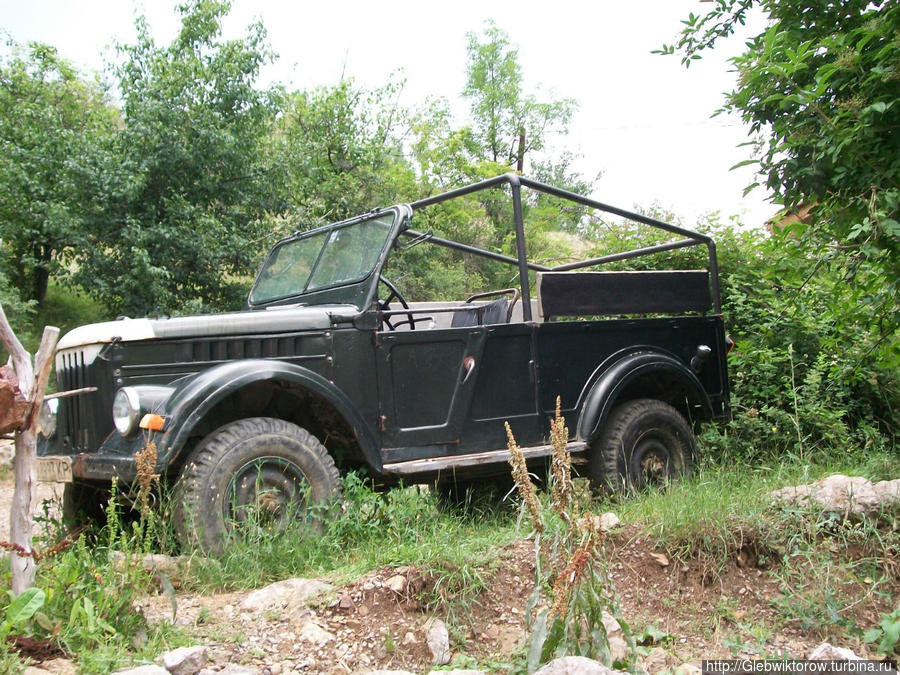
247, 205, 410, 311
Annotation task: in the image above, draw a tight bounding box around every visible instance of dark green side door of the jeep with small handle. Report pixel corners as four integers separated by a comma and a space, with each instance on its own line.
376, 323, 537, 461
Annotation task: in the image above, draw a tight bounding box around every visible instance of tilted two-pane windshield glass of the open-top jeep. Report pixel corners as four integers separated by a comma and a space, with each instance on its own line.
250, 211, 394, 303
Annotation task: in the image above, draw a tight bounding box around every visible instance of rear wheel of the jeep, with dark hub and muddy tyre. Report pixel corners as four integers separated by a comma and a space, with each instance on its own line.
590, 398, 696, 492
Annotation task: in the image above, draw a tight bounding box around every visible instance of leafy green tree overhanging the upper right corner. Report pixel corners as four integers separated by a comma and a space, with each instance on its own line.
662, 0, 900, 336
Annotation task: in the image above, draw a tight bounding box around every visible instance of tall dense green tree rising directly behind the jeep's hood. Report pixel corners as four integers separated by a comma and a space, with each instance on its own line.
77, 0, 283, 314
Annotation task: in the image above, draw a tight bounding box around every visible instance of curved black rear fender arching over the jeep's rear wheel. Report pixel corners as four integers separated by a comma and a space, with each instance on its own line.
577, 351, 712, 443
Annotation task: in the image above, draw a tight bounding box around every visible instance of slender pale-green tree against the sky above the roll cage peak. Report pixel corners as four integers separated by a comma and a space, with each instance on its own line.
463, 21, 576, 172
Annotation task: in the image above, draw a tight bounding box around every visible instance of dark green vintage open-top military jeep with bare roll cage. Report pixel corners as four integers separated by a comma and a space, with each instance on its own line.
38, 175, 729, 548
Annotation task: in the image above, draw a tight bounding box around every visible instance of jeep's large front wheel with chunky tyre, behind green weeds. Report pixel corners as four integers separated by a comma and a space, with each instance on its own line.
175, 417, 341, 552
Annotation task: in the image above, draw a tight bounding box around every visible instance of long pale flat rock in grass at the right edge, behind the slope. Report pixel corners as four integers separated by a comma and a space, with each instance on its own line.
771, 474, 900, 515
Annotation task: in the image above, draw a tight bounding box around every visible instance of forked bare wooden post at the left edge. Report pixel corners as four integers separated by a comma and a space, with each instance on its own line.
0, 306, 59, 595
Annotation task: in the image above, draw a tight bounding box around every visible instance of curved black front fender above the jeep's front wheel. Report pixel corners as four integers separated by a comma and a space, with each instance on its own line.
157, 359, 381, 472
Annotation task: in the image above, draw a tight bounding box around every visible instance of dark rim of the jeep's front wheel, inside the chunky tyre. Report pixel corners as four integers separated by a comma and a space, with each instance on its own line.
225, 457, 309, 529
